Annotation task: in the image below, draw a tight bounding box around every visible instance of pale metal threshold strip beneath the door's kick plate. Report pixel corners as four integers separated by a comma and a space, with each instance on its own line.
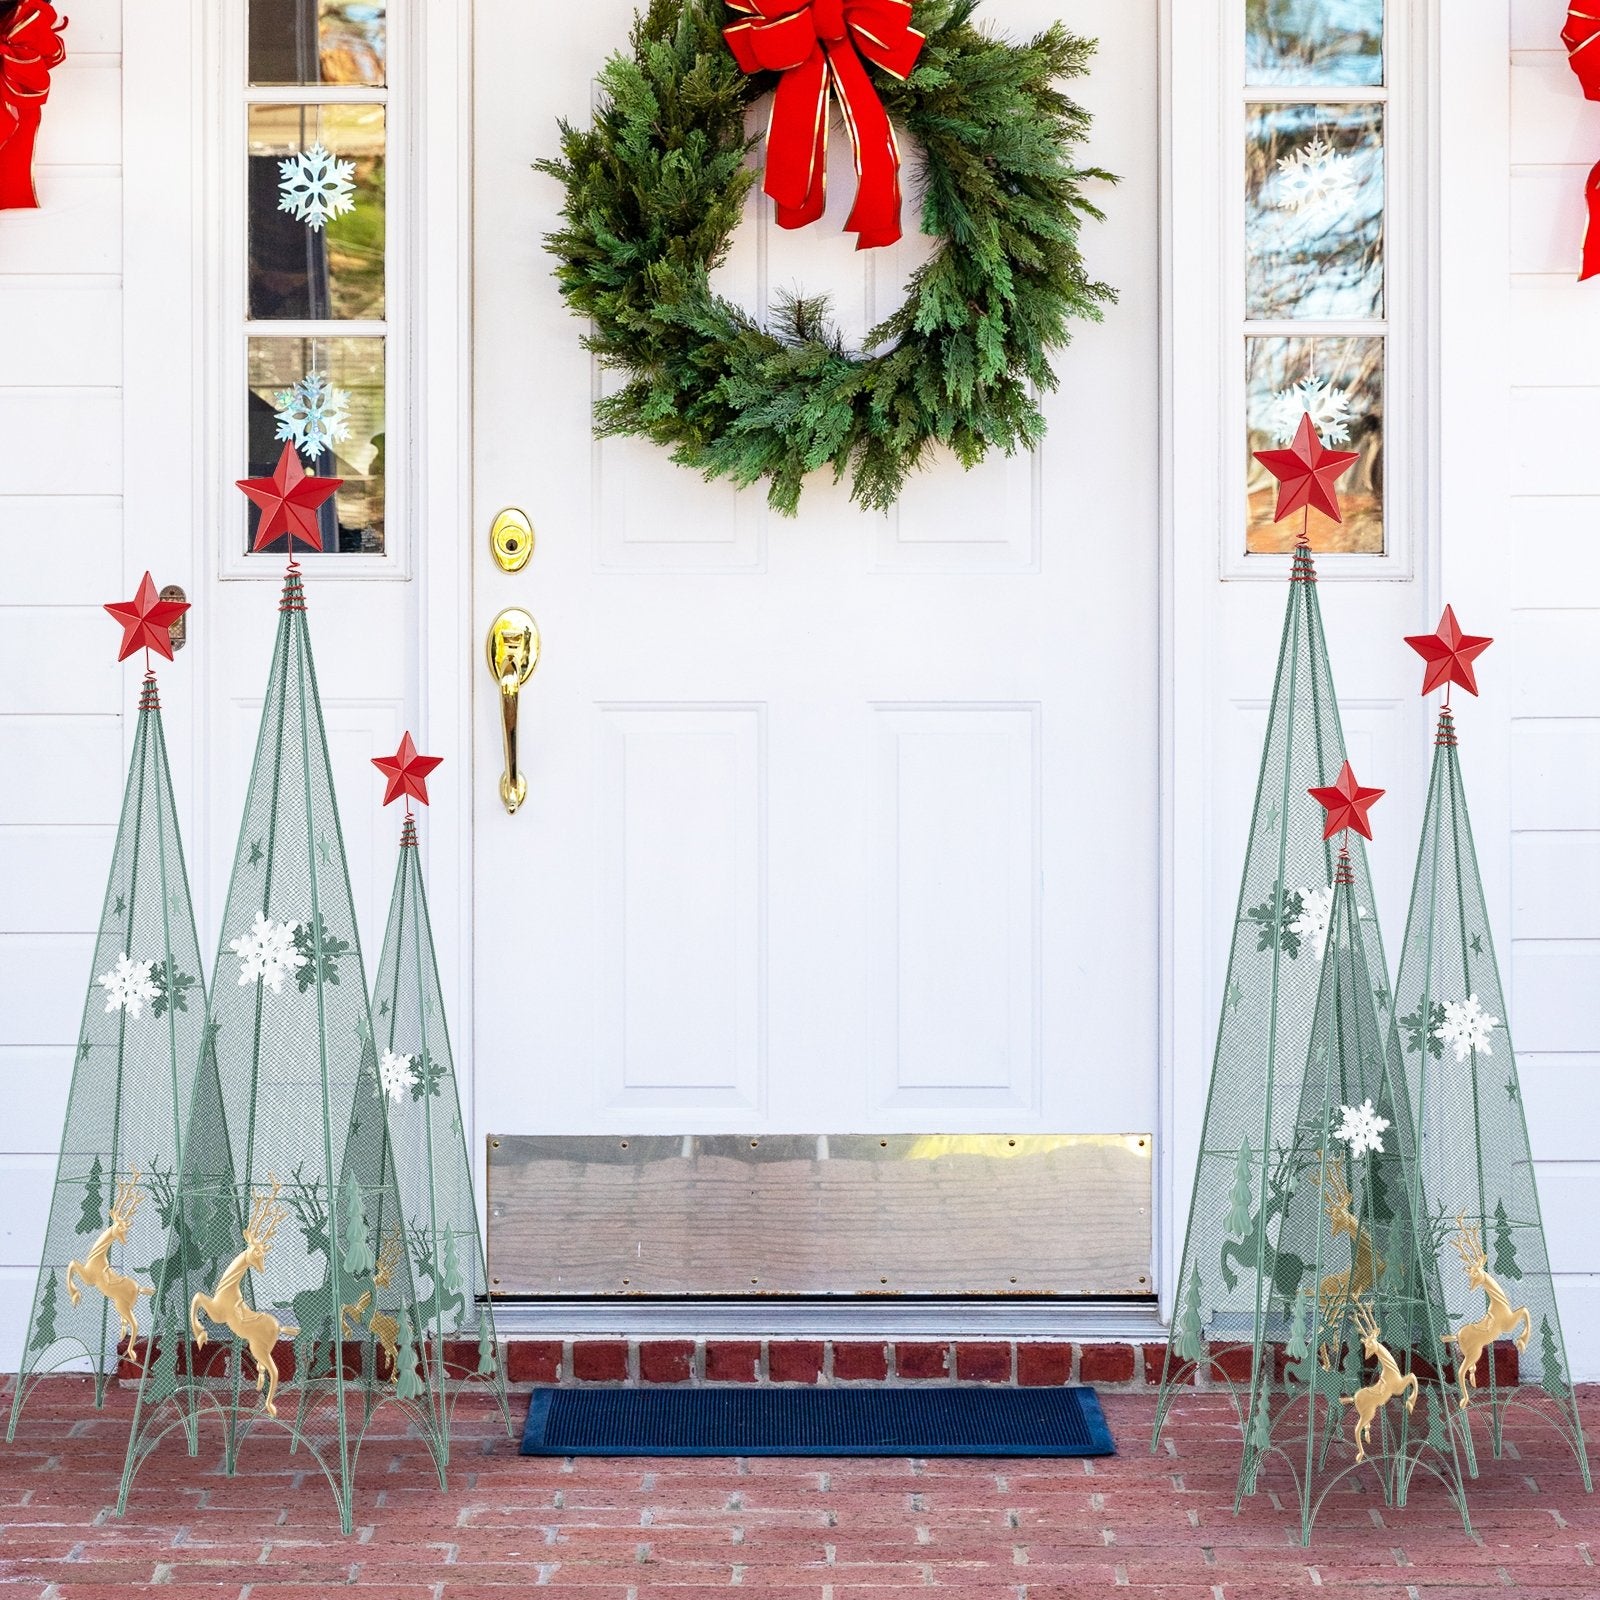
494, 1296, 1166, 1341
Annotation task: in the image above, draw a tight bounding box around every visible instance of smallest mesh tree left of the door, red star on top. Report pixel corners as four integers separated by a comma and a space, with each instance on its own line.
373, 733, 512, 1430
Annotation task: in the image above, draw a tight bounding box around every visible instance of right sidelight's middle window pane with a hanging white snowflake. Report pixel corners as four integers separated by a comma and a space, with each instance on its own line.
1245, 106, 1384, 322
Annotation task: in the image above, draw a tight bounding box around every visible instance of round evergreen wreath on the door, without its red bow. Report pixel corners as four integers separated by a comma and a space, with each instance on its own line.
538, 0, 1115, 515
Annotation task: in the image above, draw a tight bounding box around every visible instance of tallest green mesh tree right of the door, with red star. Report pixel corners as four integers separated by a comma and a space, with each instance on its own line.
1152, 418, 1456, 1536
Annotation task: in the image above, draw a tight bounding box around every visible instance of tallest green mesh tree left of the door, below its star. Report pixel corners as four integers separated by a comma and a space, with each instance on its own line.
122, 534, 446, 1531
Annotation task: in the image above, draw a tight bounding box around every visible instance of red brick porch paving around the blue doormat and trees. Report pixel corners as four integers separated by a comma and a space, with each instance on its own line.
0, 1378, 1600, 1600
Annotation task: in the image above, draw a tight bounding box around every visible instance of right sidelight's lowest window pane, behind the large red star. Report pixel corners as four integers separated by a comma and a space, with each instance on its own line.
1245, 338, 1384, 555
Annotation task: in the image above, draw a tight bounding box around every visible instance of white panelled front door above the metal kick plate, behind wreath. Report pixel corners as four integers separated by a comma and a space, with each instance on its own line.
462, 0, 1160, 1152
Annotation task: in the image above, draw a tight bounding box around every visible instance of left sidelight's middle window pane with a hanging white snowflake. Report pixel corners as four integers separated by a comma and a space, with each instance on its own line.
250, 106, 384, 322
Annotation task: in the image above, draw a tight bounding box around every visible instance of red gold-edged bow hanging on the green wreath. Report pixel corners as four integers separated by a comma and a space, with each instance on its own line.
723, 0, 926, 250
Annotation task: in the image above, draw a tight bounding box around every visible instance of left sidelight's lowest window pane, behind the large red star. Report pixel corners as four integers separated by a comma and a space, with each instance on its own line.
245, 339, 384, 554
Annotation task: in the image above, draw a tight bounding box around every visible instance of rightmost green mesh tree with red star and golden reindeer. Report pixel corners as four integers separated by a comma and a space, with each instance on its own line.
1395, 606, 1590, 1488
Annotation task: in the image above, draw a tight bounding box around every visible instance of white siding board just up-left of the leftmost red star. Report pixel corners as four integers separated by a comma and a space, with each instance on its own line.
0, 496, 122, 601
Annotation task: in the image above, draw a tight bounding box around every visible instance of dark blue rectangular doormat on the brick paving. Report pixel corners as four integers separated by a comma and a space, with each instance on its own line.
522, 1386, 1117, 1456
